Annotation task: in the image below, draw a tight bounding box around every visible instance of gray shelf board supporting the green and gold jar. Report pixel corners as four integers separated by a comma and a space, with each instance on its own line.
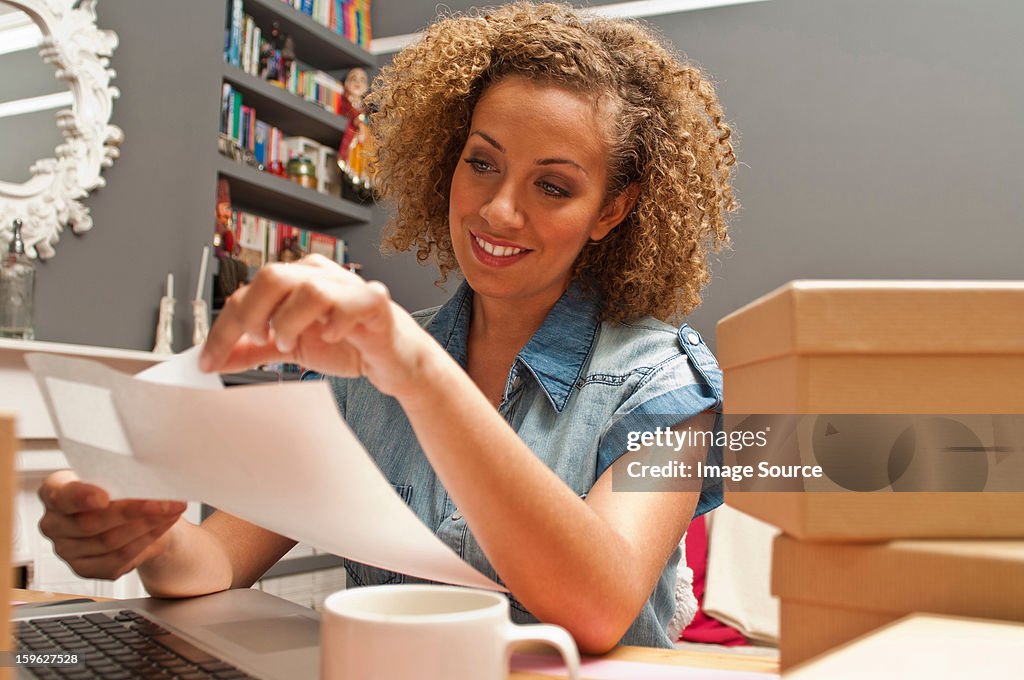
216, 155, 371, 231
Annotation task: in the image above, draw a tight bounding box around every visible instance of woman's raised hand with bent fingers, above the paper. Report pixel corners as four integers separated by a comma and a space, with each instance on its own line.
200, 255, 432, 396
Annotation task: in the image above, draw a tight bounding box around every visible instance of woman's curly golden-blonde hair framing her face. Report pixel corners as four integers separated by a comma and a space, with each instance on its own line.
367, 2, 737, 321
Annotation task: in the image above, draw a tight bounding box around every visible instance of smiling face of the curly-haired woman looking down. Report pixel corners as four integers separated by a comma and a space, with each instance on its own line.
449, 76, 630, 315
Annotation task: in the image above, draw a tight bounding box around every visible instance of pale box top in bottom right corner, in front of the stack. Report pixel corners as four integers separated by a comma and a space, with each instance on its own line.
785, 614, 1024, 680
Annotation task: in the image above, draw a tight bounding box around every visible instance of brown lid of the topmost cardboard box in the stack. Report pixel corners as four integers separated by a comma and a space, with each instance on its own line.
718, 281, 1024, 370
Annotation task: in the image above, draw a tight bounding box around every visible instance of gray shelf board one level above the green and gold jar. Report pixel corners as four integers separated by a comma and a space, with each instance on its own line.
224, 63, 348, 148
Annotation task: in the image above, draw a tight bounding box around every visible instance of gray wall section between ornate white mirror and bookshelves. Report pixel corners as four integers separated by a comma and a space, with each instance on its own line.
4, 0, 224, 349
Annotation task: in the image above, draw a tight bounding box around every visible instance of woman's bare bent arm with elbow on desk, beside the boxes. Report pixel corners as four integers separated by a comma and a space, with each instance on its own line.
400, 354, 713, 653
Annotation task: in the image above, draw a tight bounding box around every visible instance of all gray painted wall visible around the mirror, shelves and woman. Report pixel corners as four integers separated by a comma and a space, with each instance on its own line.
4, 0, 1024, 349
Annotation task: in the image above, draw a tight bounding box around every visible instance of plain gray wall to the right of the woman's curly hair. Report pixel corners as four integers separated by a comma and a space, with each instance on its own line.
374, 0, 1024, 348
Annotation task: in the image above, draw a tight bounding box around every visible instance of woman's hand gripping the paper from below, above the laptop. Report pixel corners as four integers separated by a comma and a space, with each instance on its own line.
39, 470, 186, 580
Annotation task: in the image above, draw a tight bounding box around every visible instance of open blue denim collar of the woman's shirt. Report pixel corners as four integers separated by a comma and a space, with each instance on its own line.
426, 281, 600, 412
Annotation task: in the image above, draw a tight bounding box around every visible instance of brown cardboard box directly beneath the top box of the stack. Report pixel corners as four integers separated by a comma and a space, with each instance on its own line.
772, 535, 1024, 669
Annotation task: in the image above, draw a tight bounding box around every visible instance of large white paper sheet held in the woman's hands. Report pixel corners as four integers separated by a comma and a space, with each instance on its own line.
26, 351, 504, 590
